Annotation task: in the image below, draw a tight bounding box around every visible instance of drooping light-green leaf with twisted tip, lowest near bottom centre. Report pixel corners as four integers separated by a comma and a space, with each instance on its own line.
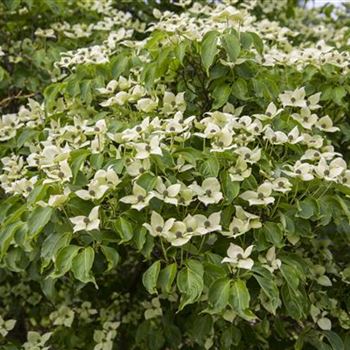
176, 260, 204, 311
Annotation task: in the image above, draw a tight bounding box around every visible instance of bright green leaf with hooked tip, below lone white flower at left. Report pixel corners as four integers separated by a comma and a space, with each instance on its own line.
72, 247, 97, 287
